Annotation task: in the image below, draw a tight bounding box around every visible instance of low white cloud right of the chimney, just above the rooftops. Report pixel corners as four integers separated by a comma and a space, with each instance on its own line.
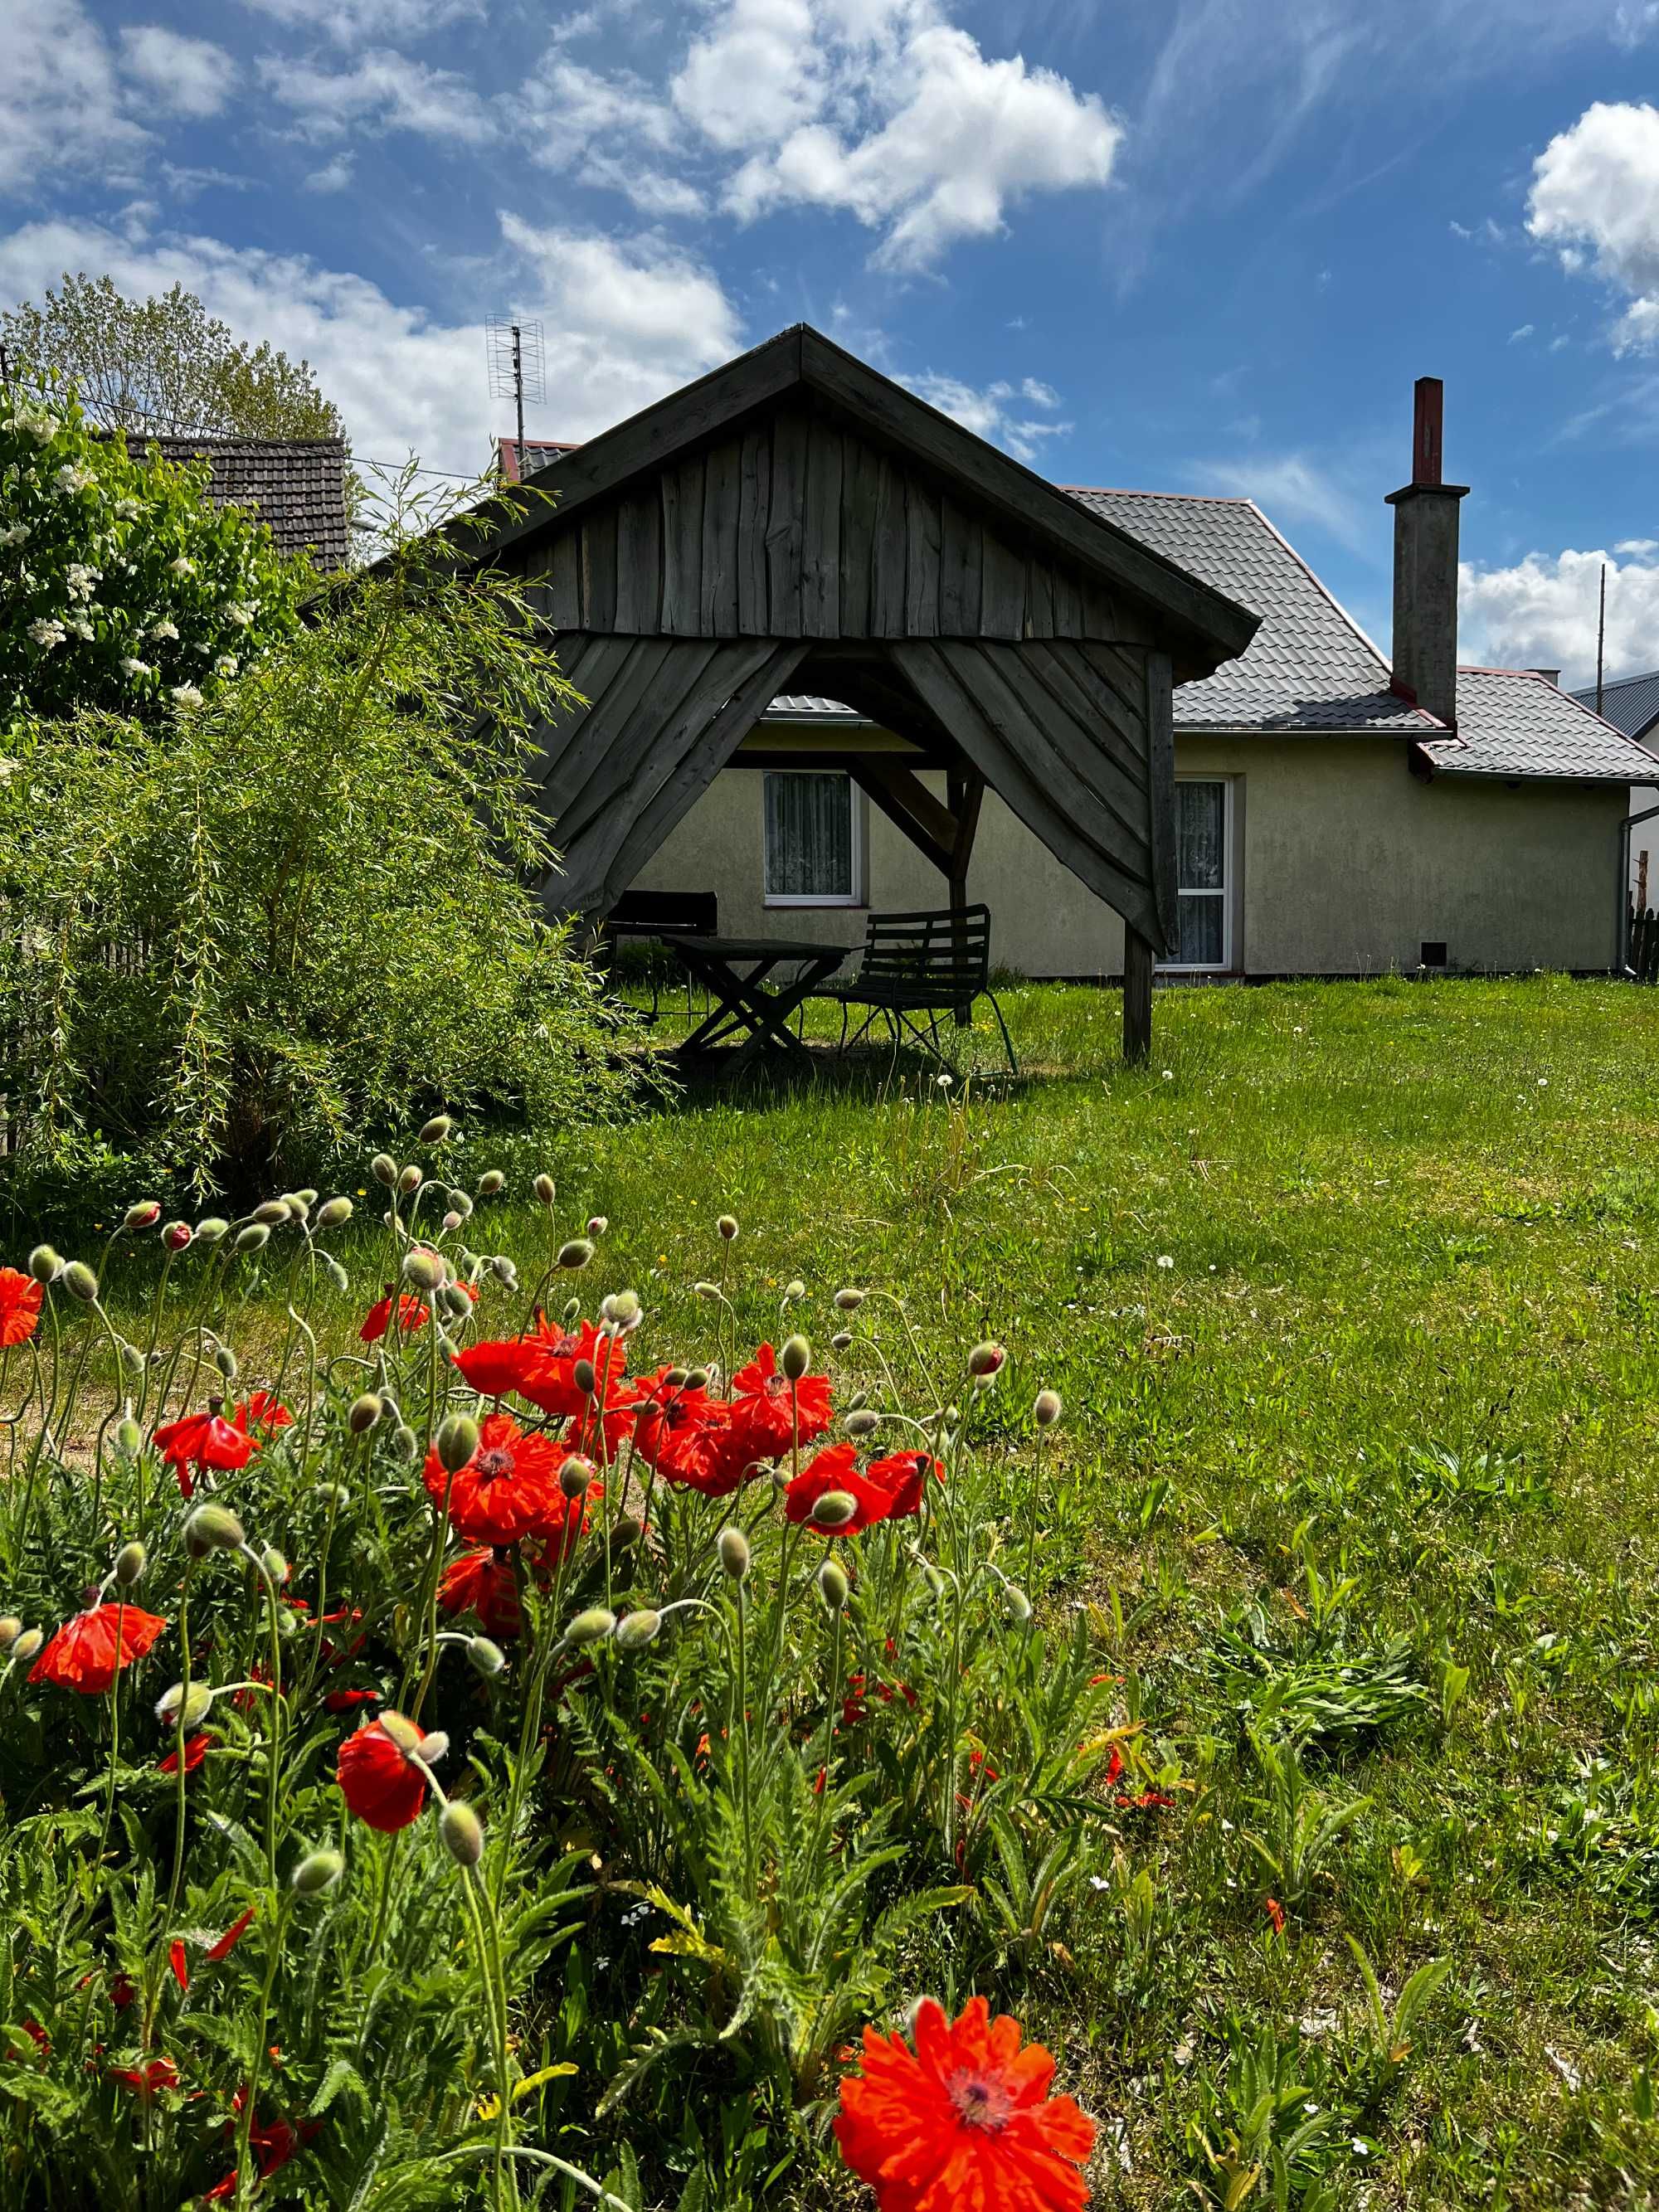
1457, 540, 1659, 690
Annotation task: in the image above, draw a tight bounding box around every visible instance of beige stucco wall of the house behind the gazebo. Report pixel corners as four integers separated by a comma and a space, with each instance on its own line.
640, 739, 1628, 975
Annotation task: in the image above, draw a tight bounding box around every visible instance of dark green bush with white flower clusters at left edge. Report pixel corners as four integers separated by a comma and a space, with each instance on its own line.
0, 382, 308, 721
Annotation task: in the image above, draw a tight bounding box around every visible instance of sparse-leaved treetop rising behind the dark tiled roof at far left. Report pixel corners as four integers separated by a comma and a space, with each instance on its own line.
0, 275, 343, 438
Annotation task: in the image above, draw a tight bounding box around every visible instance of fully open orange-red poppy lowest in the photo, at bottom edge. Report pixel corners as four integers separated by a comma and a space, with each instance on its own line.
836, 1997, 1095, 2212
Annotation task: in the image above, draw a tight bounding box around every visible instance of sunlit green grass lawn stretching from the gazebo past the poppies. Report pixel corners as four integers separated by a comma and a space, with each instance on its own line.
110, 978, 1659, 2208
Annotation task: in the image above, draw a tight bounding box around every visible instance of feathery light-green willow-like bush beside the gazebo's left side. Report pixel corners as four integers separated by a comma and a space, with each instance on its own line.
0, 484, 628, 1194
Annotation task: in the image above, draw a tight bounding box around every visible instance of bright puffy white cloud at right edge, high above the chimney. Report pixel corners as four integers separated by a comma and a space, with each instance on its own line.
1526, 100, 1659, 352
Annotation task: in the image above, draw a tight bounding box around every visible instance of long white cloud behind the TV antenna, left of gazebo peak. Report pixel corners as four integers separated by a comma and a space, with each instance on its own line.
0, 215, 743, 474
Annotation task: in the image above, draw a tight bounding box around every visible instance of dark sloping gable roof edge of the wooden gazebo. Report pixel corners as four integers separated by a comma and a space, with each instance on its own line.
475, 323, 1257, 679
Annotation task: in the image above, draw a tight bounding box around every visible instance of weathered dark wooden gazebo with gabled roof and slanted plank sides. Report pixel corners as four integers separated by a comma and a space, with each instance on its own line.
473, 325, 1257, 1055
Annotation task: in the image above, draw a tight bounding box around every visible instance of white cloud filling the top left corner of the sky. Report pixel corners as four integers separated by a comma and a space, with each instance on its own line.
0, 0, 148, 192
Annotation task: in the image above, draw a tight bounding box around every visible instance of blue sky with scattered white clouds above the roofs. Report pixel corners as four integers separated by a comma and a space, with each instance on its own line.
0, 0, 1659, 679
